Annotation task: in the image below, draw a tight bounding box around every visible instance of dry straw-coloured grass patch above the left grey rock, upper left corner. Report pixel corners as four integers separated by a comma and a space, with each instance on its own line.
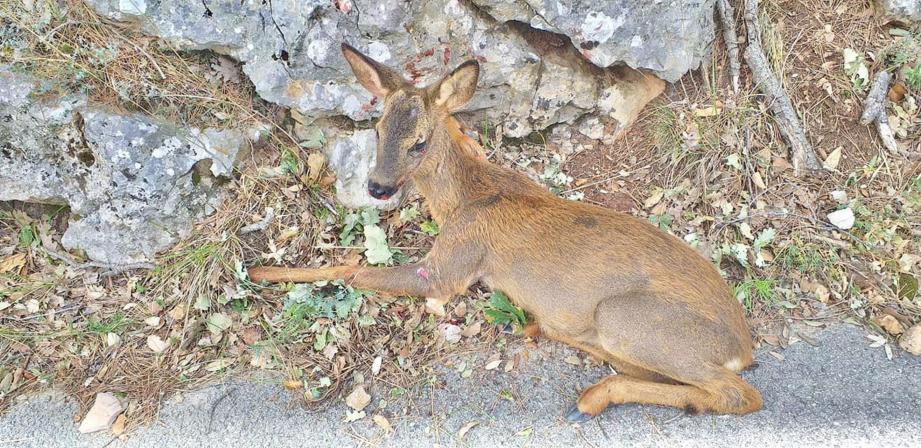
0, 0, 262, 127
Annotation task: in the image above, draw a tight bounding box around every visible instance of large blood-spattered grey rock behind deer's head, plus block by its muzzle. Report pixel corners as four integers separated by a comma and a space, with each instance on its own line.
85, 0, 688, 205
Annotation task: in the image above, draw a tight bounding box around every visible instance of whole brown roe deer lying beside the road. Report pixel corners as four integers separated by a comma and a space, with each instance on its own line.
249, 44, 762, 422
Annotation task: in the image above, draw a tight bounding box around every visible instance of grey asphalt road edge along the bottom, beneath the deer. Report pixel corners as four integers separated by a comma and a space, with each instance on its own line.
0, 325, 921, 448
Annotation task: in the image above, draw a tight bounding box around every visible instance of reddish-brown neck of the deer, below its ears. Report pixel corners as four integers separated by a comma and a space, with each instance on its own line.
413, 117, 488, 224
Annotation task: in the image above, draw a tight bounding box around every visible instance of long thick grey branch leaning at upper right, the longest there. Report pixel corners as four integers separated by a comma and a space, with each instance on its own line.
745, 0, 822, 176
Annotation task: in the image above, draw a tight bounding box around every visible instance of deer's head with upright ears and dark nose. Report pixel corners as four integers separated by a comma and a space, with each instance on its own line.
342, 43, 480, 199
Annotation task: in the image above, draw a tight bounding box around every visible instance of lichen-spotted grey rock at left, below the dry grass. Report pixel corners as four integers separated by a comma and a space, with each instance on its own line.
0, 69, 248, 265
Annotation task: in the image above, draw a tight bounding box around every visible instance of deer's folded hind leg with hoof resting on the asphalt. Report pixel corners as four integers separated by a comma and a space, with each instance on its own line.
568, 297, 762, 421
